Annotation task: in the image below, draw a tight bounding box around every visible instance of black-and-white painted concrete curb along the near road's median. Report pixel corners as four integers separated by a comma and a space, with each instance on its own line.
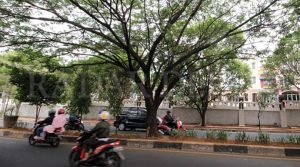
0, 130, 300, 158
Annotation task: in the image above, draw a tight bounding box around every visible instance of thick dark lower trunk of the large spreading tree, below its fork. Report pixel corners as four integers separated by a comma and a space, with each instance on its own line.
145, 98, 160, 137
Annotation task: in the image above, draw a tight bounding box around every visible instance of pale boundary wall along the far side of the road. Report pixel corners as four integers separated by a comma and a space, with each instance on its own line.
15, 102, 300, 127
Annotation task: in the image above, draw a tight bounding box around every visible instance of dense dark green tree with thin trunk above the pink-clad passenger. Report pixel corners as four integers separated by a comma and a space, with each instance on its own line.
10, 68, 64, 123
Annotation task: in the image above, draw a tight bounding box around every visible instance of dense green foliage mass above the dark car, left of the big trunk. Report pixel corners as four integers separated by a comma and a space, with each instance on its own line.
62, 58, 132, 115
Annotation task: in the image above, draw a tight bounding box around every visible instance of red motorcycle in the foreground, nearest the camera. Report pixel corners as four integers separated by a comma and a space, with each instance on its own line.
69, 132, 125, 167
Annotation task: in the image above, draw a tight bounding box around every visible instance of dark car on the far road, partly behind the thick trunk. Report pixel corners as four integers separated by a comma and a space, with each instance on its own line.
114, 107, 147, 130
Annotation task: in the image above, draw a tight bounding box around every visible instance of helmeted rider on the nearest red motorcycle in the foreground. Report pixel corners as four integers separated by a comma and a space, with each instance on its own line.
82, 111, 110, 161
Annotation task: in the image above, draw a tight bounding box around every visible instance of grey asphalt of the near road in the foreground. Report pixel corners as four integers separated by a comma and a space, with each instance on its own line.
0, 138, 300, 167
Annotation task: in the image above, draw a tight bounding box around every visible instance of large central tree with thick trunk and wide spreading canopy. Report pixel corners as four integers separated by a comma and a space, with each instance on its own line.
0, 0, 279, 136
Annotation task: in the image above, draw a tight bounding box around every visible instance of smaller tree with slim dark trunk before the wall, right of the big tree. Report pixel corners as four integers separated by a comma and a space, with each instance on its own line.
181, 60, 251, 126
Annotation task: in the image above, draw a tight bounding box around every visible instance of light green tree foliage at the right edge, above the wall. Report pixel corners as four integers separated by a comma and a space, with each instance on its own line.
264, 29, 300, 90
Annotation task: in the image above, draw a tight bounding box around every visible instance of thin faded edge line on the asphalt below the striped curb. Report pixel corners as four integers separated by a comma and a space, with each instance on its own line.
124, 147, 300, 161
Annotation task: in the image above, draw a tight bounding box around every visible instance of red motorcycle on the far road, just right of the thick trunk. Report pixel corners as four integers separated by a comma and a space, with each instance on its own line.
157, 117, 186, 135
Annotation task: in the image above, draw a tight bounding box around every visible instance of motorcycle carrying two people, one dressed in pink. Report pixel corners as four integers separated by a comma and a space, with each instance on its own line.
28, 124, 62, 147
